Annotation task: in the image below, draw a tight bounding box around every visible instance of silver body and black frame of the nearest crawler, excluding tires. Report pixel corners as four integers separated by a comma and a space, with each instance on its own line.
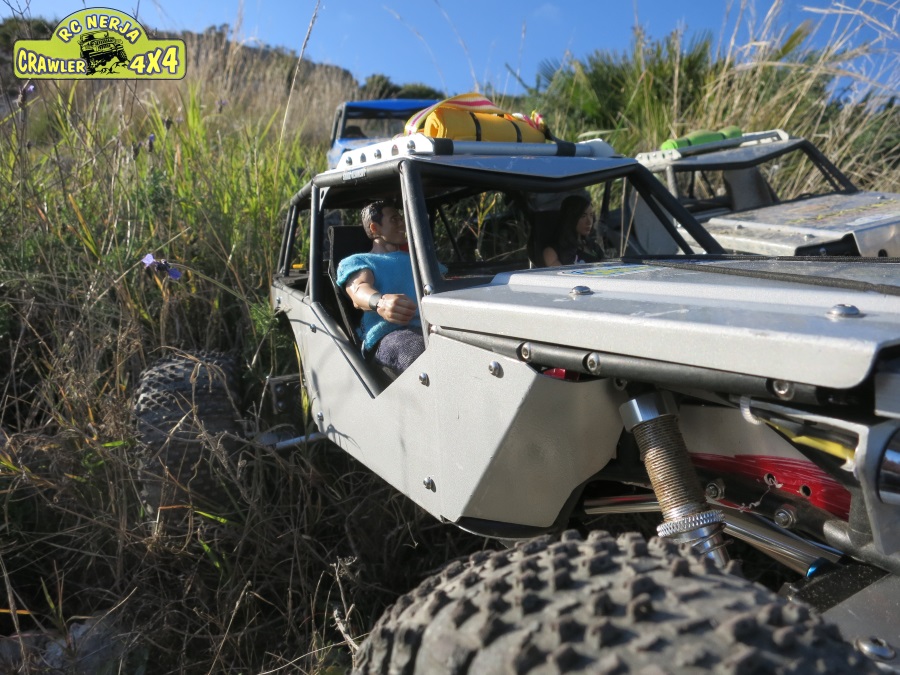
271, 135, 900, 666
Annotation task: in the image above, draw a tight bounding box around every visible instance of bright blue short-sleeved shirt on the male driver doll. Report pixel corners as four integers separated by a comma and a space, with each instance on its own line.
337, 251, 422, 354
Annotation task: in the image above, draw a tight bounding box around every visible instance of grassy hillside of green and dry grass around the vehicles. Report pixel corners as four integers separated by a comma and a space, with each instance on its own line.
0, 1, 900, 673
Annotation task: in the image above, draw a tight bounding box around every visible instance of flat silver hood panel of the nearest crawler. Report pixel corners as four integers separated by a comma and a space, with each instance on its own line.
422, 259, 900, 389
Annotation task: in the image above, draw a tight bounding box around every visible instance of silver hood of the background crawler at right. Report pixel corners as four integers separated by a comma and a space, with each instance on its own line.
697, 192, 900, 257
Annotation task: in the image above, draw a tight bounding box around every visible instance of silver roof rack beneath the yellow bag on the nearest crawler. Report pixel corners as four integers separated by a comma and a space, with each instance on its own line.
334, 134, 621, 171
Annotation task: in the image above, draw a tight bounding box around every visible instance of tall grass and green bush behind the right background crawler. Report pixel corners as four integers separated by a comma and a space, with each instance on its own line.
528, 0, 900, 190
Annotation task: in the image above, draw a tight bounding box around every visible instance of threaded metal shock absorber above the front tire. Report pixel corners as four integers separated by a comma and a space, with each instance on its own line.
619, 391, 729, 567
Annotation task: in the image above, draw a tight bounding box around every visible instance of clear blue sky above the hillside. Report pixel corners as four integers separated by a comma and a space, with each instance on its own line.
14, 0, 900, 95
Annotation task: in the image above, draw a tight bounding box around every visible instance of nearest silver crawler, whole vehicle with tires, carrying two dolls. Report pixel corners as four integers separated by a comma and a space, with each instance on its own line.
138, 129, 900, 673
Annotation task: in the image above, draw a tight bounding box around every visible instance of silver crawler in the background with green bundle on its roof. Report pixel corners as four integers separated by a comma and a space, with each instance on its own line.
637, 129, 900, 257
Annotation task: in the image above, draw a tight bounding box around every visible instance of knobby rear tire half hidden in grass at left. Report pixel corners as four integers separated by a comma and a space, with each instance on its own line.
134, 352, 242, 517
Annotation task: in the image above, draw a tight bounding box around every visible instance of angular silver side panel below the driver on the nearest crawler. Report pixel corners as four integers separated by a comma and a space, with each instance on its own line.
279, 288, 625, 527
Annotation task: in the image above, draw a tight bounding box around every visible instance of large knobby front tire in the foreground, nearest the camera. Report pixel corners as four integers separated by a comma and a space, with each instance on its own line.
355, 531, 876, 675
